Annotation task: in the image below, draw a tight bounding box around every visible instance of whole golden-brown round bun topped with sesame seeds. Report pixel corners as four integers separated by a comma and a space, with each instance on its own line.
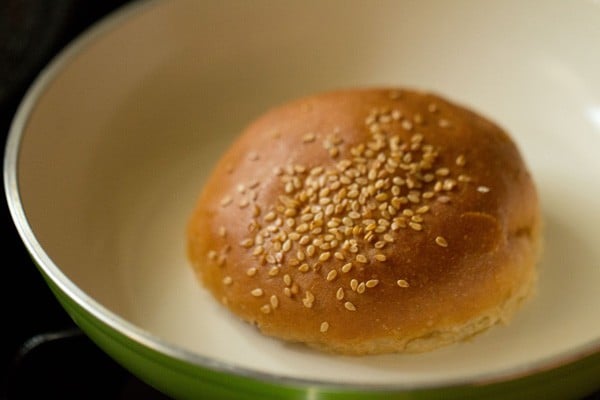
188, 88, 541, 354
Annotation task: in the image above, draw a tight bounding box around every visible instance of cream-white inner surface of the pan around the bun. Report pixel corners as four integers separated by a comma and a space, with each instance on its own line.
17, 1, 600, 385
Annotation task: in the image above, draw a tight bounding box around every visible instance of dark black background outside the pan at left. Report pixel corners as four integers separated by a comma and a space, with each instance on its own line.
0, 0, 600, 400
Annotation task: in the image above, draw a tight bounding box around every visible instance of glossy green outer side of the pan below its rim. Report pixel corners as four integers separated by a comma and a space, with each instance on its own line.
40, 269, 600, 400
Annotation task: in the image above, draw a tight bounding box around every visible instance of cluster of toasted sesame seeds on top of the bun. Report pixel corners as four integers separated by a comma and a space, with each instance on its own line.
229, 98, 468, 312
